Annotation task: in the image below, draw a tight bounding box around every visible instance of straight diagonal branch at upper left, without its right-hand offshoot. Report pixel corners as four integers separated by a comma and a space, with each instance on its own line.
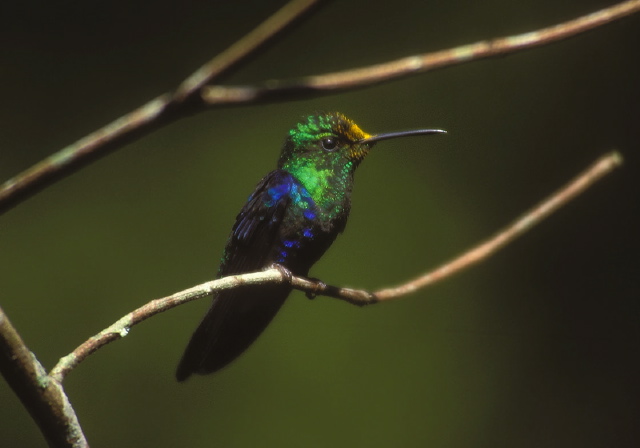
0, 0, 320, 214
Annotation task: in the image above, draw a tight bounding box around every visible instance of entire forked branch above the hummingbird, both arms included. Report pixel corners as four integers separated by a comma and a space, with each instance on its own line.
0, 0, 640, 214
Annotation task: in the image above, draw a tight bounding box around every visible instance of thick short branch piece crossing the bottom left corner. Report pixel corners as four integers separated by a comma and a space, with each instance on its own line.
0, 308, 88, 448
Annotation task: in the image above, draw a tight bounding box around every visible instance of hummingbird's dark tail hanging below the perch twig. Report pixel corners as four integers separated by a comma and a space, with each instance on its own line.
176, 285, 291, 381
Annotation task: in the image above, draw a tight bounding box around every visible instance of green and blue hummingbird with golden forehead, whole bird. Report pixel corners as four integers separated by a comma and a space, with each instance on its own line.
176, 112, 445, 381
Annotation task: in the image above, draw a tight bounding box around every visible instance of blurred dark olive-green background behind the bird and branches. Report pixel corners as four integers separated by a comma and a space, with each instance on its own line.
0, 0, 640, 448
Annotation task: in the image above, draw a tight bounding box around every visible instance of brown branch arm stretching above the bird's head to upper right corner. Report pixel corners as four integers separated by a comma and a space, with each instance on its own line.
203, 0, 640, 106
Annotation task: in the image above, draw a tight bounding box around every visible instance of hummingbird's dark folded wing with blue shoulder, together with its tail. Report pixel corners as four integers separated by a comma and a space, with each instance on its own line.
176, 170, 296, 381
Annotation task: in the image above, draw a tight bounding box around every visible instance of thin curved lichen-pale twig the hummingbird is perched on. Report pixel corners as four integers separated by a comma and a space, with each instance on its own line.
50, 152, 622, 382
